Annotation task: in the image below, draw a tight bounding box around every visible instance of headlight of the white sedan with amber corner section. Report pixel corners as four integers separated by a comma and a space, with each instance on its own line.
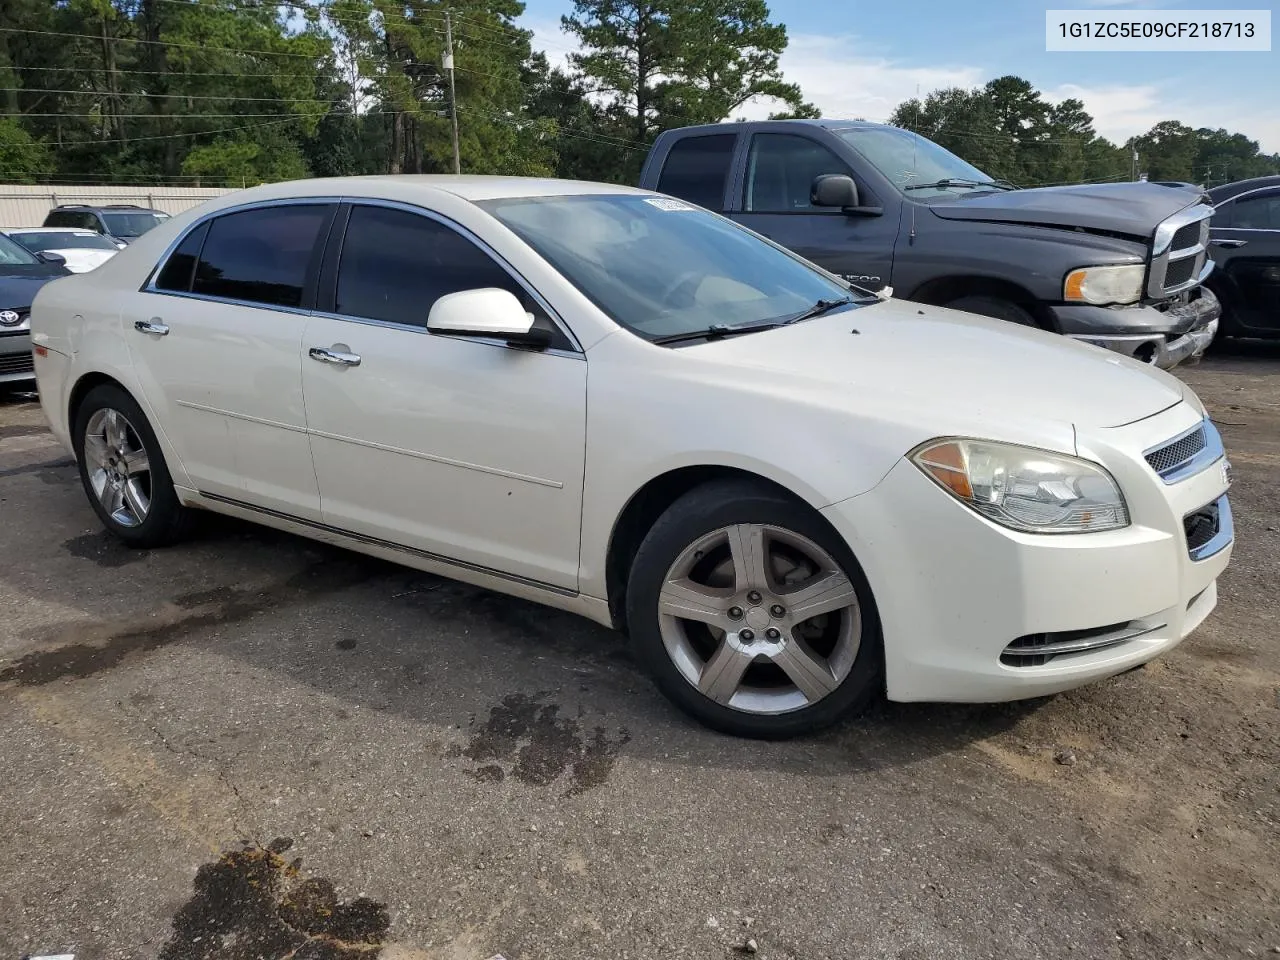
911, 439, 1129, 534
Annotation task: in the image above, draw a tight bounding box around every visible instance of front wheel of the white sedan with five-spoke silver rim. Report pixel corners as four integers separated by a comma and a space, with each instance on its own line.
627, 480, 883, 740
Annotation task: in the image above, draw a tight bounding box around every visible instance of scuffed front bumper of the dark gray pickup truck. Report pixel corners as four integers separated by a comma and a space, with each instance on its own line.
1050, 287, 1222, 370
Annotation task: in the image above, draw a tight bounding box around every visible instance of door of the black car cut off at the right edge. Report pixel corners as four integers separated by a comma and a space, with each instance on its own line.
1210, 187, 1280, 335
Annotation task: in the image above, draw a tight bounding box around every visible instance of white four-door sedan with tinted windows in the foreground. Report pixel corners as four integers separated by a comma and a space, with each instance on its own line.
32, 177, 1233, 737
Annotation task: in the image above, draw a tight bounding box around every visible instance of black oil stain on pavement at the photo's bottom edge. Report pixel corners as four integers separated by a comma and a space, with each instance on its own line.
160, 837, 390, 960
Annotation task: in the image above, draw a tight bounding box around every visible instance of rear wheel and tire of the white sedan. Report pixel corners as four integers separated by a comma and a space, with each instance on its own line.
72, 384, 191, 548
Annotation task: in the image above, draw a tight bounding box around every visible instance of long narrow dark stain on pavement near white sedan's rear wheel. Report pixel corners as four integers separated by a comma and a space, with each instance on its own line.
0, 558, 381, 686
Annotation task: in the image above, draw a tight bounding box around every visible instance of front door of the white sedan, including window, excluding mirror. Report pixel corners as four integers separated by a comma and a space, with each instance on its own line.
302, 204, 586, 589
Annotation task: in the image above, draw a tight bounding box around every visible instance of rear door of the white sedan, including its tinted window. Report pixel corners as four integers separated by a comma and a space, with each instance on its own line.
122, 202, 335, 520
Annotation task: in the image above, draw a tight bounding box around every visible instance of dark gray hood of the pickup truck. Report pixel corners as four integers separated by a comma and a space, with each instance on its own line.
928, 183, 1204, 239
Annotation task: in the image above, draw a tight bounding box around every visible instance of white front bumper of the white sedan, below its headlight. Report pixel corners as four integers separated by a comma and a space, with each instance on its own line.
823, 403, 1233, 703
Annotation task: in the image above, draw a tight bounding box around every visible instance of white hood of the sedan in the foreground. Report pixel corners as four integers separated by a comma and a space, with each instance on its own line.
686, 301, 1184, 435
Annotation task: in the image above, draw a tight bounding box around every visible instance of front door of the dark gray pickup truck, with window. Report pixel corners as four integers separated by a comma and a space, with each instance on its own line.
731, 133, 899, 289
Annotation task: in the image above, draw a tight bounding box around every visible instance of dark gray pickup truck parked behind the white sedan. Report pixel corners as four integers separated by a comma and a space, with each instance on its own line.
640, 120, 1221, 367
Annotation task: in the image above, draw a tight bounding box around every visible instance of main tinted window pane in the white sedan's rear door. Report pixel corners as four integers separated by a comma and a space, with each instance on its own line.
192, 204, 329, 307
